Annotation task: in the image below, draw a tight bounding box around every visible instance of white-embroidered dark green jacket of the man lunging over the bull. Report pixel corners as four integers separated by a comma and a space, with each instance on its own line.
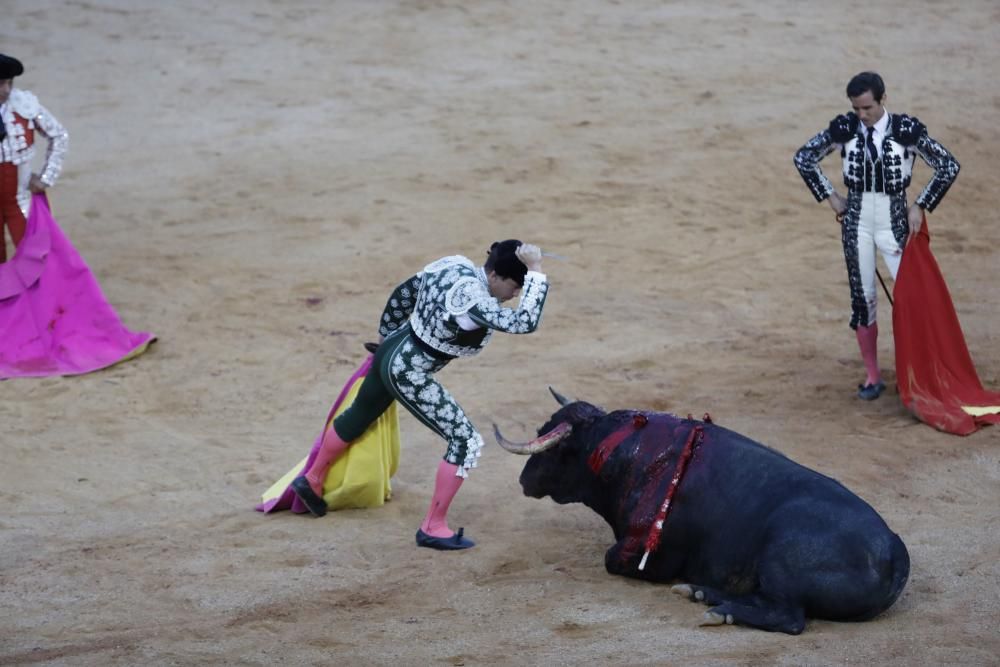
379, 255, 549, 357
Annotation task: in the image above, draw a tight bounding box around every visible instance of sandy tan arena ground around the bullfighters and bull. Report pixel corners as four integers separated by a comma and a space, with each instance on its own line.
0, 0, 1000, 666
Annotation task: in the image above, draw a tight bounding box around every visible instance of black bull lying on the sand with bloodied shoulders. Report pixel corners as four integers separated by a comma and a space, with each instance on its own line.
496, 392, 910, 634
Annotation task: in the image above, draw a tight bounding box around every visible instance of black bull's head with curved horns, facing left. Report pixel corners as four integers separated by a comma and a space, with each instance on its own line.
493, 387, 605, 503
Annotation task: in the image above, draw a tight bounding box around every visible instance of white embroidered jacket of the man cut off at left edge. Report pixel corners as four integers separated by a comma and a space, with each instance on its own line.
0, 88, 69, 218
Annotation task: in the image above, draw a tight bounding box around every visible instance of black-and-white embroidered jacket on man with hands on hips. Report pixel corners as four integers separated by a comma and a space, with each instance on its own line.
795, 113, 960, 212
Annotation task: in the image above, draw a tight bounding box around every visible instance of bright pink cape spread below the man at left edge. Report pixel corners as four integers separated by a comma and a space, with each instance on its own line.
0, 194, 156, 379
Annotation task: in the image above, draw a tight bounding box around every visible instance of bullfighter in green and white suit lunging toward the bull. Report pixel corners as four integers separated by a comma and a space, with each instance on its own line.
292, 240, 549, 550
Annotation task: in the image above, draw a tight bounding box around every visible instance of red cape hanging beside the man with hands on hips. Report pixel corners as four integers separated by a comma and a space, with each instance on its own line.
892, 218, 1000, 435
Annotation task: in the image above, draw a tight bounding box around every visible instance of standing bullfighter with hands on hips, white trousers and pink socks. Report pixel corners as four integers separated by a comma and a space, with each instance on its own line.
795, 72, 959, 400
